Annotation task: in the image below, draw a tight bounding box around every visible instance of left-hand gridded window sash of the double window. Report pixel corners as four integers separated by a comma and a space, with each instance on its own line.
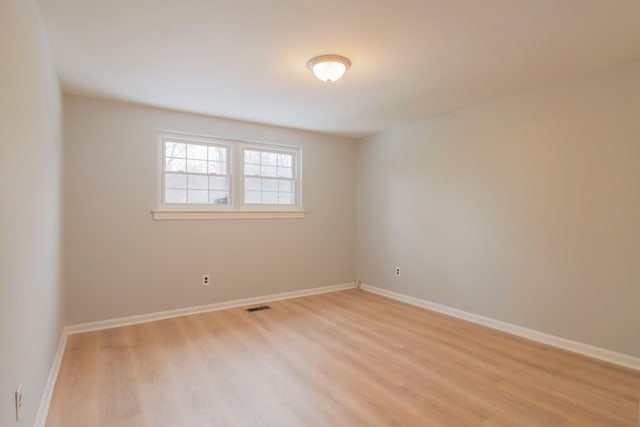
163, 139, 231, 205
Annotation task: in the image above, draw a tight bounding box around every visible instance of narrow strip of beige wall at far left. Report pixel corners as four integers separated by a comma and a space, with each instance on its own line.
0, 0, 64, 426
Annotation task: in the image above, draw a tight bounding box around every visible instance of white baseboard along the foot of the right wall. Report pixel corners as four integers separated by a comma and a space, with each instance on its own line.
360, 283, 640, 371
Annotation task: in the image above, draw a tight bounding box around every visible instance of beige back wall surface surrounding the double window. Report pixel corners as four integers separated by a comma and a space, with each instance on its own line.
64, 95, 355, 323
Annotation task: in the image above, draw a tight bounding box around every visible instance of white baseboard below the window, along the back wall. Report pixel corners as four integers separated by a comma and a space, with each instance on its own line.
67, 283, 355, 334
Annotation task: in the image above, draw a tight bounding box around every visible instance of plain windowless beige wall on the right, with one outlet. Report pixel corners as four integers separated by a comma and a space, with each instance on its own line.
357, 62, 640, 356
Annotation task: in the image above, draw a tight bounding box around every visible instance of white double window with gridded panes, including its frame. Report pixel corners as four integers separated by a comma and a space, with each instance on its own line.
154, 133, 302, 219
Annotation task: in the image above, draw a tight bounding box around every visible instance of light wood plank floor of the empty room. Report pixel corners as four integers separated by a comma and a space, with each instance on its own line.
47, 289, 640, 427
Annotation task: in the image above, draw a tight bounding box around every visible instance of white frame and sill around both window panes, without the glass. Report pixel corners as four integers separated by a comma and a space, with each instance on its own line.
152, 131, 306, 220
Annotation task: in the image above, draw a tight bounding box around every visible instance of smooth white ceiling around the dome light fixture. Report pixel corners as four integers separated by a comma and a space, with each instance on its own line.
39, 0, 640, 136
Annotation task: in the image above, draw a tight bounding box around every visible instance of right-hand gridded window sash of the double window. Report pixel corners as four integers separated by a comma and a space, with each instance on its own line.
242, 147, 297, 206
